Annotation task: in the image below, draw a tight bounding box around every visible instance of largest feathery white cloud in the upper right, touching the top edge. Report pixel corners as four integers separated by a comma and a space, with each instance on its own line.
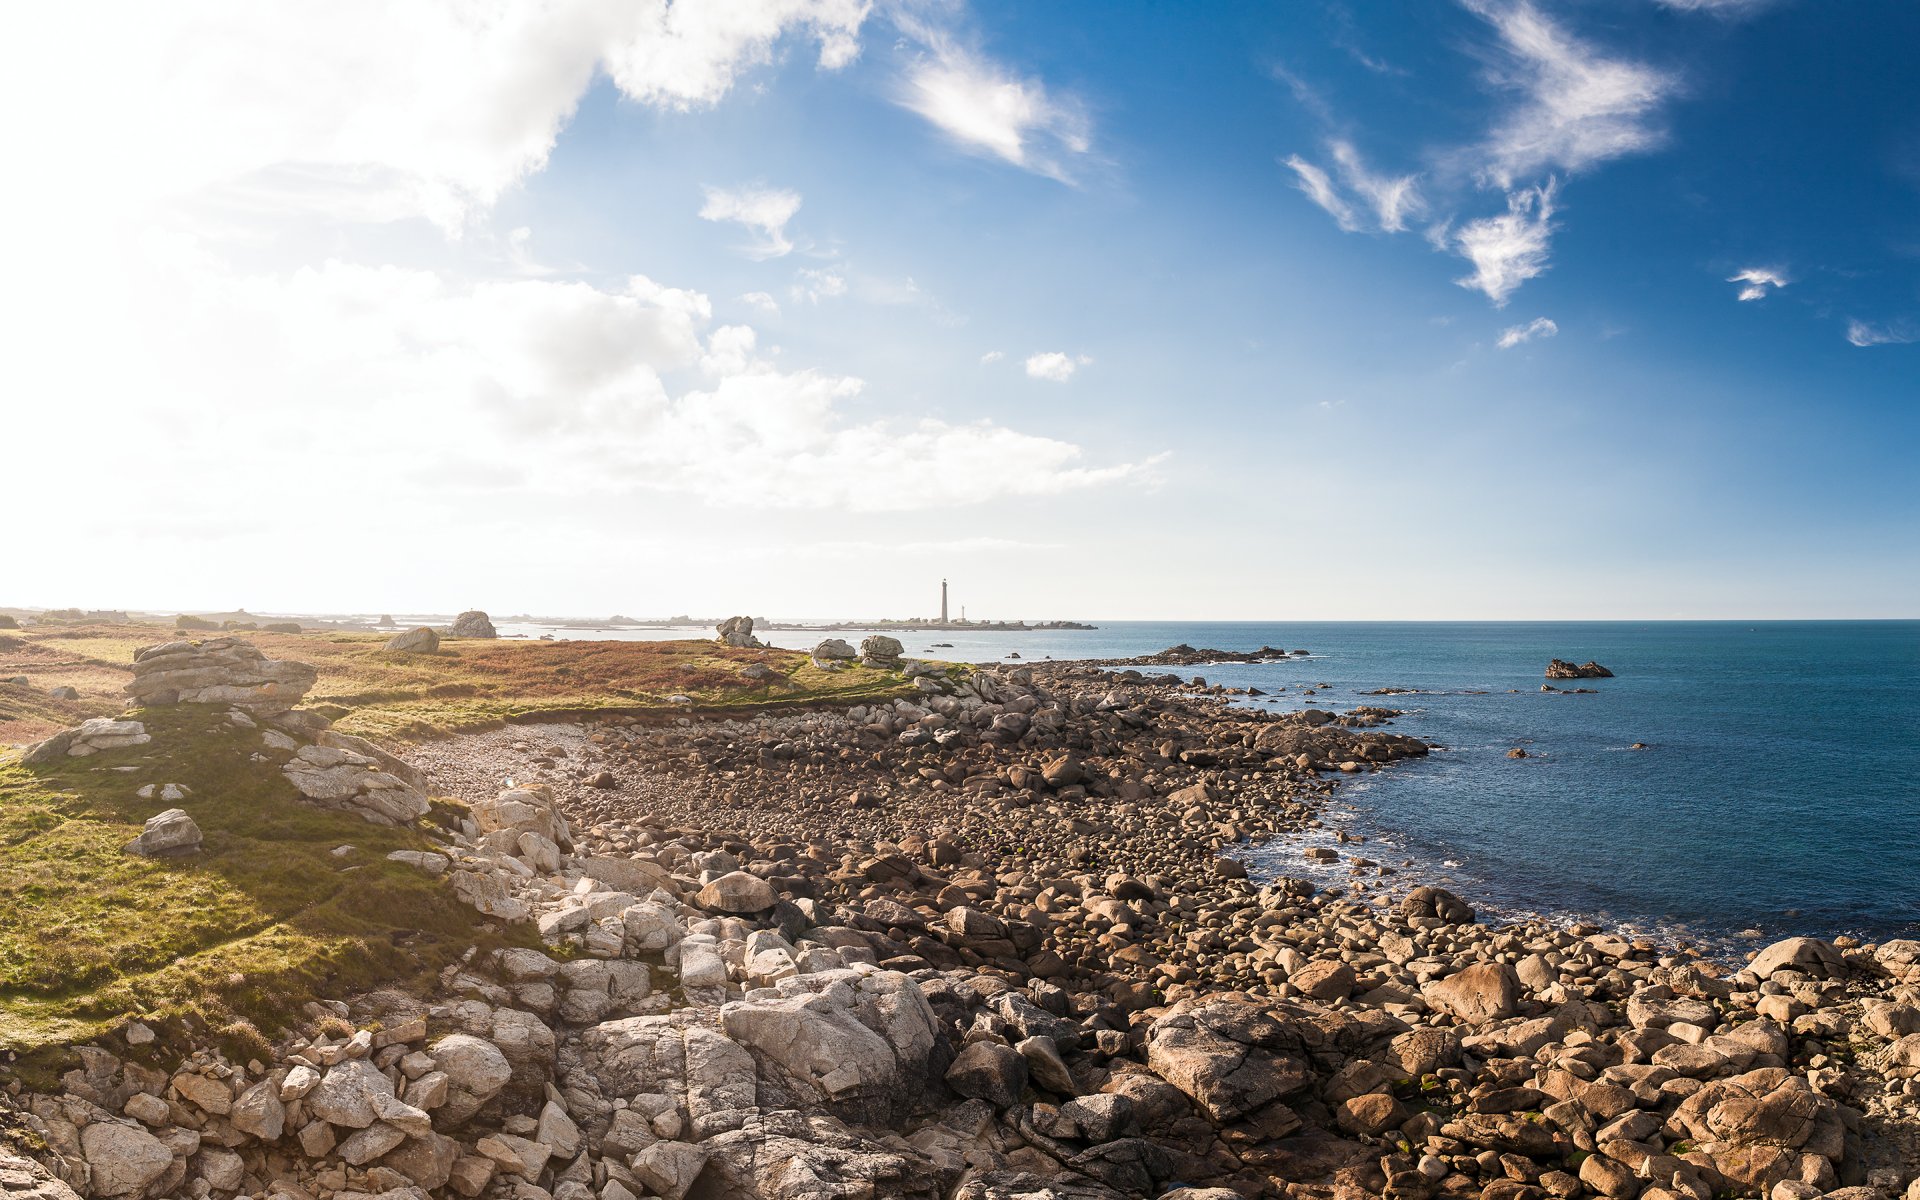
1465, 0, 1678, 188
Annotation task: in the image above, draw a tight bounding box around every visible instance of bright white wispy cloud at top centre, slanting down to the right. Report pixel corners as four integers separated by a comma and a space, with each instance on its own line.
897, 19, 1092, 182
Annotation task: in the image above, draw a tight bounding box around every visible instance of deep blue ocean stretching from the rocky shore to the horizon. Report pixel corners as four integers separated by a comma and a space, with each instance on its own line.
501, 620, 1920, 945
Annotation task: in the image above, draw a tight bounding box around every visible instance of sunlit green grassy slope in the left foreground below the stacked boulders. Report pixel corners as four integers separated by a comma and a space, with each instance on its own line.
0, 707, 532, 1050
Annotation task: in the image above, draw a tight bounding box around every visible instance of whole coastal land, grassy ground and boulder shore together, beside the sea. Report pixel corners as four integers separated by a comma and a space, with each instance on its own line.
0, 626, 1920, 1200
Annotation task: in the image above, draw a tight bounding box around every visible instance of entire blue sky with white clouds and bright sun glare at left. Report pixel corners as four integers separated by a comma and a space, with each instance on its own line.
0, 0, 1920, 620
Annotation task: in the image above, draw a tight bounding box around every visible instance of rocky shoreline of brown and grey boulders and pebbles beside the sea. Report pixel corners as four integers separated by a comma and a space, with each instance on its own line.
0, 664, 1920, 1200
